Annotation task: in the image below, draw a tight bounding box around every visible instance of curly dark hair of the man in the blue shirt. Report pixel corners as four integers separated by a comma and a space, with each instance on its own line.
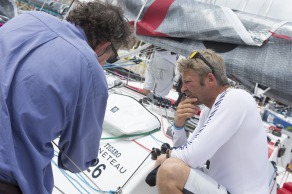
66, 0, 132, 49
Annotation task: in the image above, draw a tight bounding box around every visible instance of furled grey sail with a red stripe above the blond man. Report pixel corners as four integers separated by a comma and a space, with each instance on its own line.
118, 0, 292, 106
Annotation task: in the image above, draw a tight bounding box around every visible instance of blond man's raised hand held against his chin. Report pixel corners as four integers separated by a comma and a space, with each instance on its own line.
174, 98, 200, 127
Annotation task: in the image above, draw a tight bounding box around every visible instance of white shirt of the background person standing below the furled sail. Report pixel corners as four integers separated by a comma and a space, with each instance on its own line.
143, 51, 176, 97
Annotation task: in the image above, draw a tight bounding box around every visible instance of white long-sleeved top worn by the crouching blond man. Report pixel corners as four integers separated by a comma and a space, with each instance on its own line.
171, 89, 272, 194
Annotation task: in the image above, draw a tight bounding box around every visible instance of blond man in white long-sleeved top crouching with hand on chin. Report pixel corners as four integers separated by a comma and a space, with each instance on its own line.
156, 49, 274, 194
